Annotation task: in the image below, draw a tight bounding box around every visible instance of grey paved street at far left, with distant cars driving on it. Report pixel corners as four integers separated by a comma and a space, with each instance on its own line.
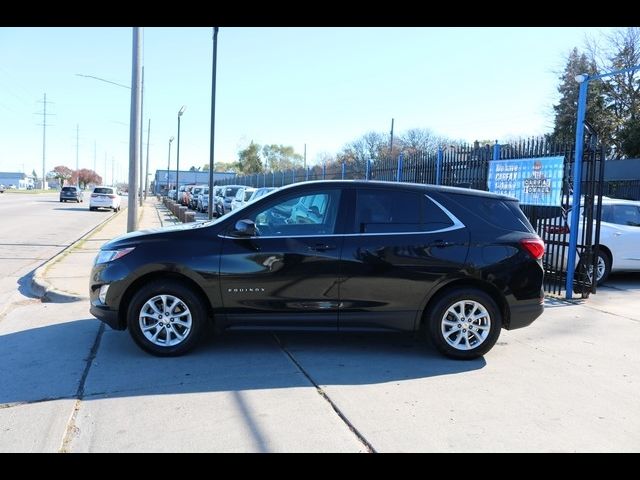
0, 192, 117, 318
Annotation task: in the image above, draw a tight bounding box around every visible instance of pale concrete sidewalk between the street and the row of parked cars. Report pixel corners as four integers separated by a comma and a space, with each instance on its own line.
32, 197, 180, 303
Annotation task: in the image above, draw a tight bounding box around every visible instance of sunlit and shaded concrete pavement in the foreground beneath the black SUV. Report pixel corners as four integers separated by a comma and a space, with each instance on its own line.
0, 197, 640, 452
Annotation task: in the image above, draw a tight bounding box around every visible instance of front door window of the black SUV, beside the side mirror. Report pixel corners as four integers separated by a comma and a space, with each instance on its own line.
242, 190, 340, 236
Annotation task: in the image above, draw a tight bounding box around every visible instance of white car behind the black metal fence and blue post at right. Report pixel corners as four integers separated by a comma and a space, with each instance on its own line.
545, 197, 640, 285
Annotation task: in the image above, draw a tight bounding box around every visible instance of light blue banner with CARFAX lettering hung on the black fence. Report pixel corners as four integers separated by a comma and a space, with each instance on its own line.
487, 157, 564, 206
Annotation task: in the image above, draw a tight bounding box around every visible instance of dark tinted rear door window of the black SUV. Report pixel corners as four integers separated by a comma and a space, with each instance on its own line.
354, 190, 453, 233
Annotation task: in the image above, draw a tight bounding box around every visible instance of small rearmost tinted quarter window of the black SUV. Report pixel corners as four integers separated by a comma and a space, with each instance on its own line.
455, 195, 535, 233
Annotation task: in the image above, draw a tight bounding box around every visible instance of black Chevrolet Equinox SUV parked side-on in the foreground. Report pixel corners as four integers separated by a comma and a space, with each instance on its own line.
90, 181, 544, 359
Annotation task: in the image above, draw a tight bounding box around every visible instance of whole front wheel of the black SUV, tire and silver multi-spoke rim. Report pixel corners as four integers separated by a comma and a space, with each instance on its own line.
127, 280, 207, 357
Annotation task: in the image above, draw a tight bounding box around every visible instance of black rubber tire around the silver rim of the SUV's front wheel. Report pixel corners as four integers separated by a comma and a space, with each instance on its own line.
127, 280, 207, 357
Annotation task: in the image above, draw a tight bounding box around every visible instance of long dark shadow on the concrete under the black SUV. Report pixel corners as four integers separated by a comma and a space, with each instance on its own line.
0, 319, 486, 404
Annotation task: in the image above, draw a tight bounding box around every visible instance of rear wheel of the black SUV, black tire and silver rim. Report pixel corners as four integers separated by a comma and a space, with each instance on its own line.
425, 288, 502, 360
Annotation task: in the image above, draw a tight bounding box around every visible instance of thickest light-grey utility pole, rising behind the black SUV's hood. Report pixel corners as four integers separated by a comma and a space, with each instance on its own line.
127, 27, 141, 232
